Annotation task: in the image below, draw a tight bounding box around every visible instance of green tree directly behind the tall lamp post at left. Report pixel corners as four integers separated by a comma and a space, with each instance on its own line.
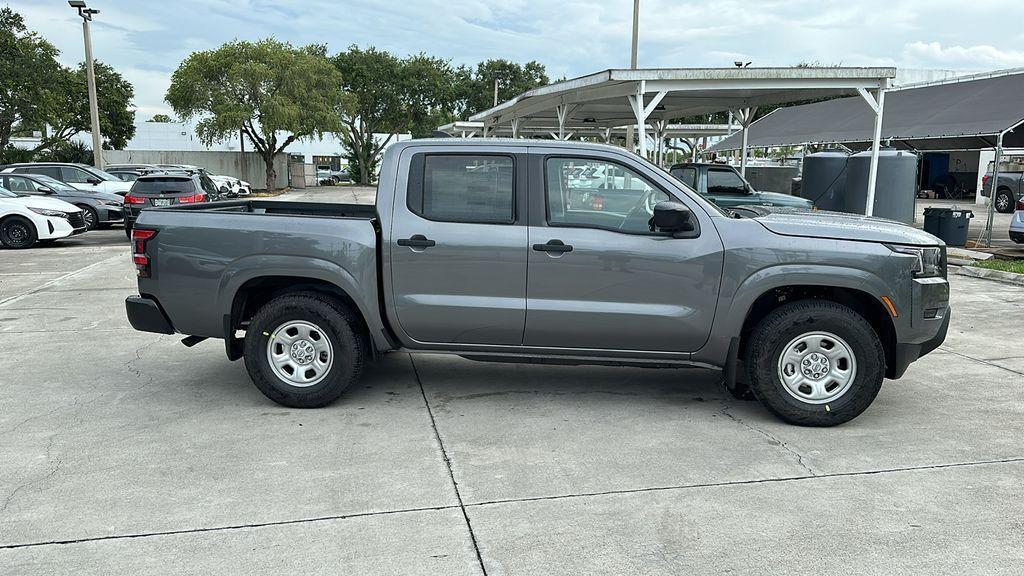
36, 60, 135, 152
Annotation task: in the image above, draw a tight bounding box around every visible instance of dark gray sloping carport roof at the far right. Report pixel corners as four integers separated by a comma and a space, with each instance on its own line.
710, 69, 1024, 152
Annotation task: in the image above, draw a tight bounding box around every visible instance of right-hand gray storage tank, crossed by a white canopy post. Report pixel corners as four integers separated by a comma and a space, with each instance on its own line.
845, 150, 918, 224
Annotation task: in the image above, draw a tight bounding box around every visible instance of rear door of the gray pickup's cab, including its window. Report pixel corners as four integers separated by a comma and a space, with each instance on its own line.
384, 146, 526, 345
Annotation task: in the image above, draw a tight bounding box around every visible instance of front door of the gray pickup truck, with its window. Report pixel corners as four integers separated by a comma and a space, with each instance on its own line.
523, 155, 723, 353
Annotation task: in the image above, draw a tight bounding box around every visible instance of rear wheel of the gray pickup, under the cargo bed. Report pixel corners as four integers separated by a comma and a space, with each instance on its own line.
244, 292, 369, 408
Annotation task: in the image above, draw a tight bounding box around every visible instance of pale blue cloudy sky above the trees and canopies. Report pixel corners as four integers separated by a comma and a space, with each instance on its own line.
8, 0, 1024, 118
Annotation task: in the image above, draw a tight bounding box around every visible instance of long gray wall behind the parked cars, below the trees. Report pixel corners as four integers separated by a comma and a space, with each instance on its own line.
103, 150, 288, 190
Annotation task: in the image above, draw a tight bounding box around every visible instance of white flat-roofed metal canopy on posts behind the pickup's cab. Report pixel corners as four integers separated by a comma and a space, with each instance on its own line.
469, 68, 896, 214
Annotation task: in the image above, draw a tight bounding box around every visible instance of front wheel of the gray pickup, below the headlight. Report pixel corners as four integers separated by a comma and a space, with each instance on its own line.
745, 300, 886, 426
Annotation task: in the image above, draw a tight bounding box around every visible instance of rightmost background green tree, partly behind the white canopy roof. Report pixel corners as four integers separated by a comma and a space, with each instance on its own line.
461, 59, 550, 117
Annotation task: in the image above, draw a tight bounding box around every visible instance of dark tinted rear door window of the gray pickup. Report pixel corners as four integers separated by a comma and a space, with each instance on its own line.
407, 154, 515, 224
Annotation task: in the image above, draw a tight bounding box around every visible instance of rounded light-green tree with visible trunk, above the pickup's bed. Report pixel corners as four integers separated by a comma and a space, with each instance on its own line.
166, 38, 348, 190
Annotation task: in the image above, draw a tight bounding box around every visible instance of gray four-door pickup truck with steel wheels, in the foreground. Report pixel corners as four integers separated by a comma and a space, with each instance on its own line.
126, 138, 950, 425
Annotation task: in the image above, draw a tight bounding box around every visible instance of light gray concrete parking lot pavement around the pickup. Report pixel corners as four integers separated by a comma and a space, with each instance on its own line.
0, 188, 1024, 575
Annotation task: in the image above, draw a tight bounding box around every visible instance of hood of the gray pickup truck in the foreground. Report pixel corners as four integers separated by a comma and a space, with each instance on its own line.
748, 206, 943, 246
